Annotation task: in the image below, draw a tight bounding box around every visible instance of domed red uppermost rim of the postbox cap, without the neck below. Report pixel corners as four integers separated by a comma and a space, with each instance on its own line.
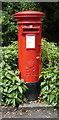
13, 10, 45, 18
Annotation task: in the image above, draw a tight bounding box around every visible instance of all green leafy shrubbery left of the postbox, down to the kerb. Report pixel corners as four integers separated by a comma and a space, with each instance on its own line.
0, 42, 28, 107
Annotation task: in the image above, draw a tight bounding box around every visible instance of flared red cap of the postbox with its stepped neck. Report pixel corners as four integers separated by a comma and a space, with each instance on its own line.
13, 10, 45, 24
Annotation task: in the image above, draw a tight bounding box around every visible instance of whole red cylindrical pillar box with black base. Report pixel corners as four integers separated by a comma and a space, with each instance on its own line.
13, 10, 45, 100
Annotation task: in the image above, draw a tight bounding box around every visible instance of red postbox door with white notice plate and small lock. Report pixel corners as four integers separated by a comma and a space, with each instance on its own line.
25, 34, 41, 82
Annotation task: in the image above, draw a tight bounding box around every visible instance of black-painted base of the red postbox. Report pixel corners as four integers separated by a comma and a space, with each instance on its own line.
25, 81, 40, 101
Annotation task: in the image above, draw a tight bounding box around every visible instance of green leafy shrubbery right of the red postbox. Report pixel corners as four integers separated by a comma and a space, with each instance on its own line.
39, 39, 59, 106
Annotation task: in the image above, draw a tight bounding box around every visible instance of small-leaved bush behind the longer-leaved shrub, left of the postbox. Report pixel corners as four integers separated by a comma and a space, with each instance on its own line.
2, 41, 18, 71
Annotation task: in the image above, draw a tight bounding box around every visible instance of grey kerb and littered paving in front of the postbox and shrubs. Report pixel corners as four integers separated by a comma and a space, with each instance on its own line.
0, 102, 58, 120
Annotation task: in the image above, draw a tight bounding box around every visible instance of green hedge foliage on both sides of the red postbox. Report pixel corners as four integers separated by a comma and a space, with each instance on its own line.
0, 39, 59, 106
